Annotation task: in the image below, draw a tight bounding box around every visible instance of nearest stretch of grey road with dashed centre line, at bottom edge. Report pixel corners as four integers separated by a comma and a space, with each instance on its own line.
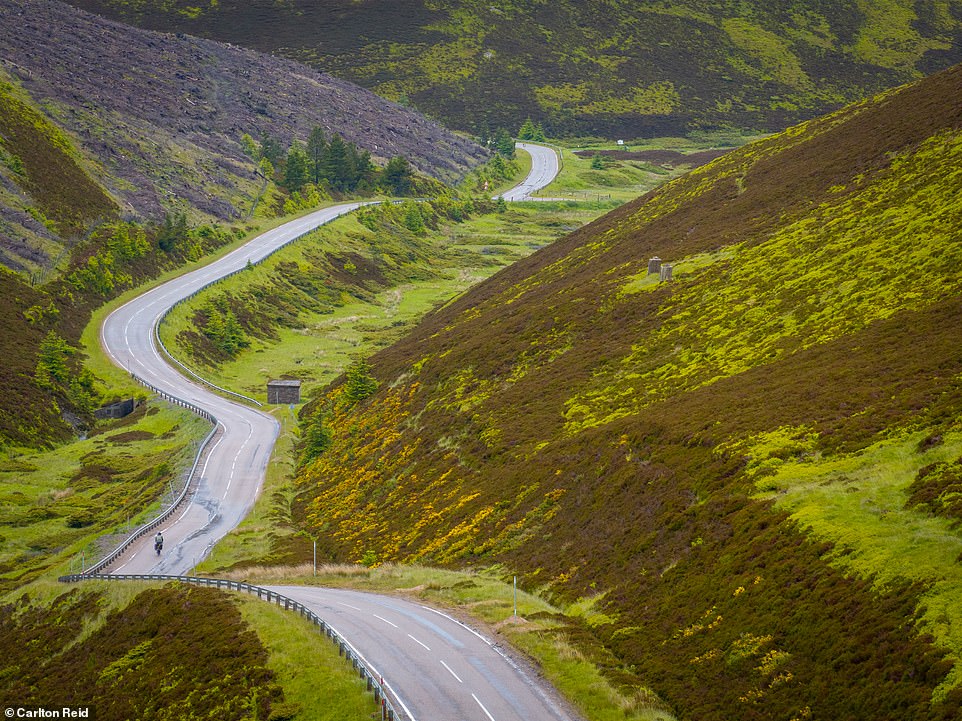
269, 586, 574, 721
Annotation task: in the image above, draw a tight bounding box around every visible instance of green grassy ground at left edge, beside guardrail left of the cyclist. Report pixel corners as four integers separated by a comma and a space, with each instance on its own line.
0, 403, 209, 589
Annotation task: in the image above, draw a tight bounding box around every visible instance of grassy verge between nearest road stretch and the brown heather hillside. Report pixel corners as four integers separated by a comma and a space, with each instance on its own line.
215, 565, 673, 721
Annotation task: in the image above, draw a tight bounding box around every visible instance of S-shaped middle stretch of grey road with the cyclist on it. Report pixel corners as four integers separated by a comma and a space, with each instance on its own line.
101, 203, 362, 575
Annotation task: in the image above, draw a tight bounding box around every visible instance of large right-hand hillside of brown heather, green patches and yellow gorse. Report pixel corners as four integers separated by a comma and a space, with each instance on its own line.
295, 67, 962, 720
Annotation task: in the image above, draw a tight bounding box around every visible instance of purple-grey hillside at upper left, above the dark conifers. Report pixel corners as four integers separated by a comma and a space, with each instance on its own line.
0, 0, 484, 270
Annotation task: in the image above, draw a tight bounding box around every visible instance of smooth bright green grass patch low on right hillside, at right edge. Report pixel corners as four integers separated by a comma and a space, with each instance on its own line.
749, 433, 962, 692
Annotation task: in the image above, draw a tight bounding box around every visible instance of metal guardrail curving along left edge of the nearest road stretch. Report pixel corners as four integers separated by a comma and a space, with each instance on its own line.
58, 574, 409, 721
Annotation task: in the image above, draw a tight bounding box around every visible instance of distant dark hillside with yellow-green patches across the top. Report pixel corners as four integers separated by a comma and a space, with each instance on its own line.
62, 0, 962, 138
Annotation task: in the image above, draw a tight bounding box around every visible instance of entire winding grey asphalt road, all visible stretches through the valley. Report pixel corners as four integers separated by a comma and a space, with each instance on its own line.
101, 150, 573, 721
